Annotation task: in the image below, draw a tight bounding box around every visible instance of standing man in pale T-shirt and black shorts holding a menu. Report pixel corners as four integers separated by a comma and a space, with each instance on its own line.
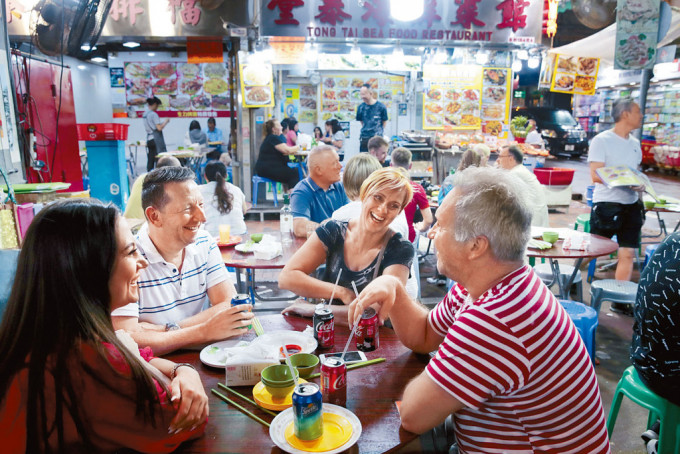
588, 98, 645, 281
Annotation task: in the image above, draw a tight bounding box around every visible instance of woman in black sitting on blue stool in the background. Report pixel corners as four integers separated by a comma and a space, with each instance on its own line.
255, 119, 300, 191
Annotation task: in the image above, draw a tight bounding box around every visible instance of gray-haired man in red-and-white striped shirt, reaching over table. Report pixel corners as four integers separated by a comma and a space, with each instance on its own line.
349, 168, 610, 453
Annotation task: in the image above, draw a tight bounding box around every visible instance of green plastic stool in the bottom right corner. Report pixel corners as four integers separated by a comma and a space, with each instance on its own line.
607, 366, 680, 453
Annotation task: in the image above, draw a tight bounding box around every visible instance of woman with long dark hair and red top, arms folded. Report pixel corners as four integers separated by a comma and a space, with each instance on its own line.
0, 199, 208, 453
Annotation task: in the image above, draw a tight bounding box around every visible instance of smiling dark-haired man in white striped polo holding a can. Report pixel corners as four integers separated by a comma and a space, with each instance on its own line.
111, 167, 252, 354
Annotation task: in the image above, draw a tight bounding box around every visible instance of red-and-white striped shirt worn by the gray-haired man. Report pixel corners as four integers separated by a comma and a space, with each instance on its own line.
426, 266, 610, 453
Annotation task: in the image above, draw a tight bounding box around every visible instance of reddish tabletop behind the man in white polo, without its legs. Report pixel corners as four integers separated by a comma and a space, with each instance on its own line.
220, 221, 306, 270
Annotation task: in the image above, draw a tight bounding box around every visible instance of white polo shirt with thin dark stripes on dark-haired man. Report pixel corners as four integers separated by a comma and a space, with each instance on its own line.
111, 224, 227, 325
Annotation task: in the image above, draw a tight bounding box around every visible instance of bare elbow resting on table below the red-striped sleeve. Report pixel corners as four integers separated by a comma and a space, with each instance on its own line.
399, 371, 464, 434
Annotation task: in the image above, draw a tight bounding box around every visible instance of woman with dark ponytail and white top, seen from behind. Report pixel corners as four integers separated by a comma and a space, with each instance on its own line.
198, 161, 248, 238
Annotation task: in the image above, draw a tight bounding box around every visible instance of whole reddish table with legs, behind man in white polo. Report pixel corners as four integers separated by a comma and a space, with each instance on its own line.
220, 221, 306, 301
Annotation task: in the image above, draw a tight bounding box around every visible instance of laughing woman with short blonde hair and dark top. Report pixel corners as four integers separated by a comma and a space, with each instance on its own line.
279, 168, 414, 324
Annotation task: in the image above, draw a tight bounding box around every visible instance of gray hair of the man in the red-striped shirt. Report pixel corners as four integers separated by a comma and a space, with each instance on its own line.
453, 167, 532, 262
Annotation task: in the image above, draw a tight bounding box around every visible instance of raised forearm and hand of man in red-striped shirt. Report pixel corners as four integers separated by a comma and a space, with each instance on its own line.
348, 276, 444, 353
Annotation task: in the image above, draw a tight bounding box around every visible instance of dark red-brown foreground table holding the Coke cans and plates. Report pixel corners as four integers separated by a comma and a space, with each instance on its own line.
166, 314, 430, 454
